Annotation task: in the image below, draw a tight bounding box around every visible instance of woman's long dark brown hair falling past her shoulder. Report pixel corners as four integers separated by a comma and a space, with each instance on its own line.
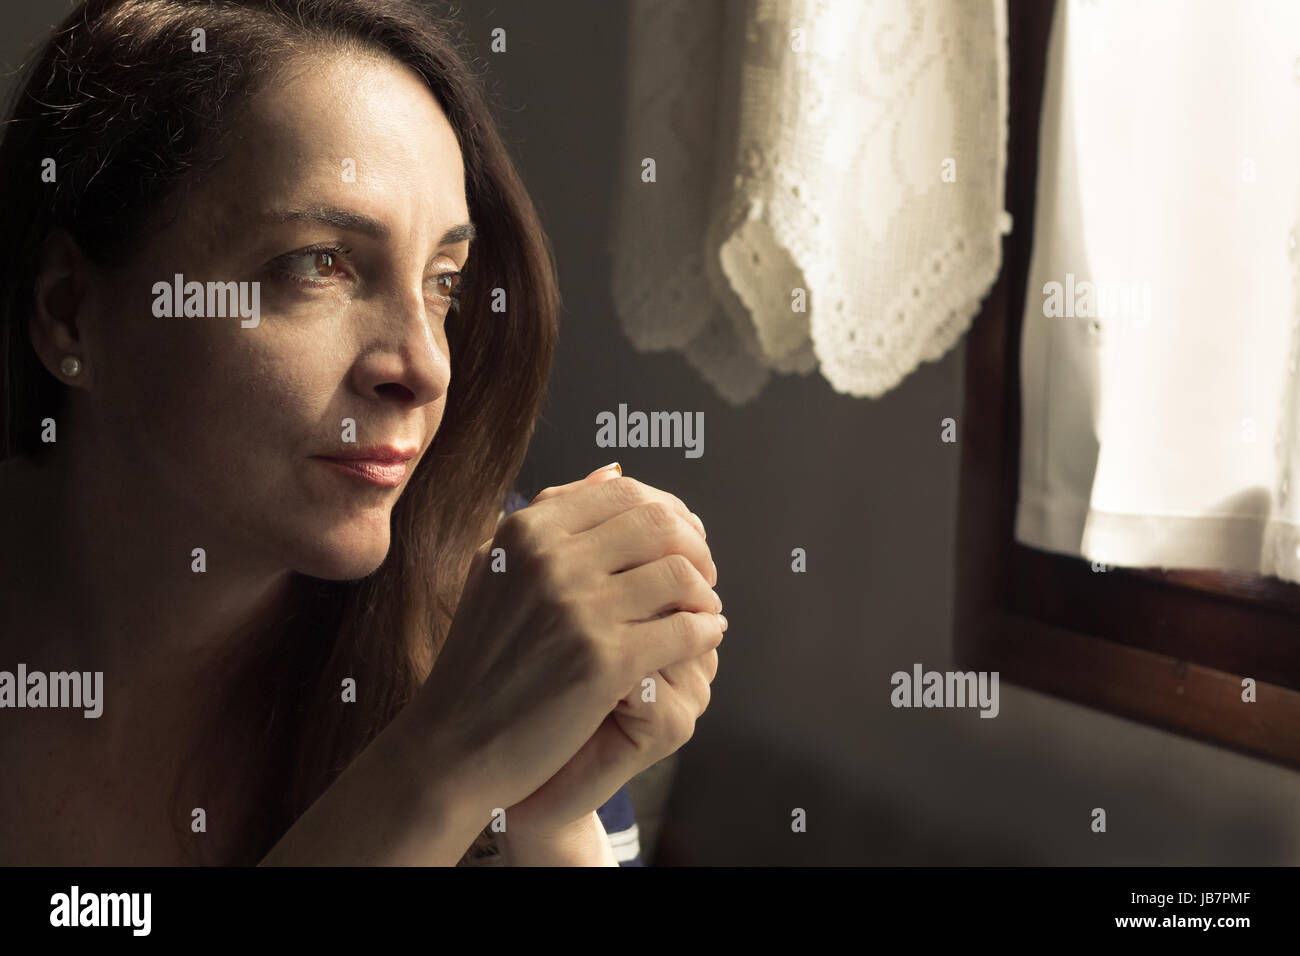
0, 0, 560, 865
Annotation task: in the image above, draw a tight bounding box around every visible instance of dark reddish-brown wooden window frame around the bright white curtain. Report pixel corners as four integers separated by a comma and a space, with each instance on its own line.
954, 0, 1300, 769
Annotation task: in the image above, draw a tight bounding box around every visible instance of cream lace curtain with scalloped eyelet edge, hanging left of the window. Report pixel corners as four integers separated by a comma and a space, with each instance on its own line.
610, 0, 1010, 405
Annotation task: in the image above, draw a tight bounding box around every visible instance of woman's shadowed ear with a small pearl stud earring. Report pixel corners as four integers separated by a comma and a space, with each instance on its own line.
27, 229, 95, 388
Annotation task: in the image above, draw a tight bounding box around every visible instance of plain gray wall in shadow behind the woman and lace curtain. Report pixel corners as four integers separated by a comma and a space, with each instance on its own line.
10, 0, 1300, 865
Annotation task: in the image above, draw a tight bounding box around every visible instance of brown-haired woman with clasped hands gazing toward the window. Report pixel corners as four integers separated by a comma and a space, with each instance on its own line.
0, 0, 725, 865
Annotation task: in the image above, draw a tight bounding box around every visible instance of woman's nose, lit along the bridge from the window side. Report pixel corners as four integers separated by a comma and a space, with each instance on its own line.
352, 283, 451, 407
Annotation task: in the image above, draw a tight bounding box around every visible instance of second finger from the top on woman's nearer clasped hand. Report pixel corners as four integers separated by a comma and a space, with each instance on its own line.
572, 501, 718, 590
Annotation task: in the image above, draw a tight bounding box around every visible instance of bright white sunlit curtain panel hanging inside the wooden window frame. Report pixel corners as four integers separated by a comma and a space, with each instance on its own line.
1015, 0, 1300, 581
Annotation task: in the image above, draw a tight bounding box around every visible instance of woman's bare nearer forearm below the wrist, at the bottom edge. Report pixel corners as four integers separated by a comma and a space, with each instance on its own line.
260, 718, 488, 866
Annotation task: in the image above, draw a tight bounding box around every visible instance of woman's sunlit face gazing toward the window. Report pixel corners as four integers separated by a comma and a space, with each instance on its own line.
69, 53, 469, 580
